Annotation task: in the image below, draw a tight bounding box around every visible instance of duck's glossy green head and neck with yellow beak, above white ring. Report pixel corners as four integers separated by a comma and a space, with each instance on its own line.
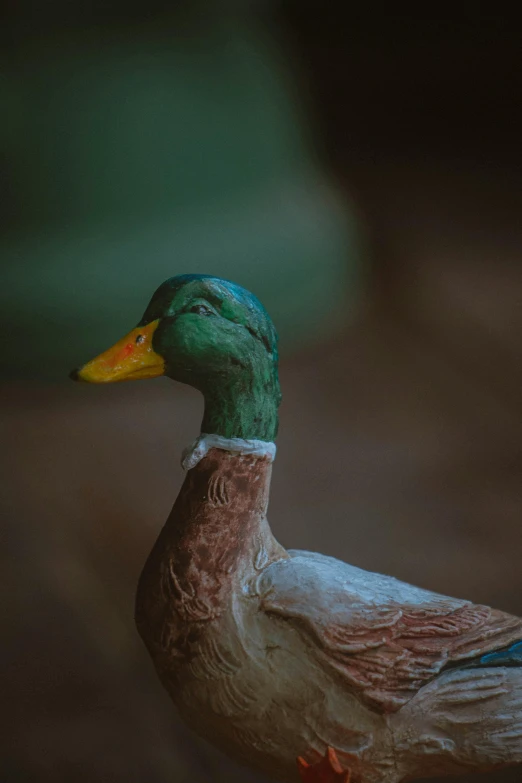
73, 275, 281, 441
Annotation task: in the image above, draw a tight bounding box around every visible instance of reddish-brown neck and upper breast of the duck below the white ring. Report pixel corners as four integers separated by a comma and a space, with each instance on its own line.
136, 448, 288, 665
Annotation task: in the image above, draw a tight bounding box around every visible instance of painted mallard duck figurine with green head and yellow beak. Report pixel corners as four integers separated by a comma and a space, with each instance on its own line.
72, 275, 522, 783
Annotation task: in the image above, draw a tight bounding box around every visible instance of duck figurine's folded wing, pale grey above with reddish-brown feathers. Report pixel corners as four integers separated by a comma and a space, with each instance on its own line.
256, 551, 522, 713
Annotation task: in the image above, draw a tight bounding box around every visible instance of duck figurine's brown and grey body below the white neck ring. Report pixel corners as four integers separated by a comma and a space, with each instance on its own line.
136, 449, 522, 783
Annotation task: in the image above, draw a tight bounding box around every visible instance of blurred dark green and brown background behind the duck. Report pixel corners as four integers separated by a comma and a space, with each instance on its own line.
0, 6, 522, 783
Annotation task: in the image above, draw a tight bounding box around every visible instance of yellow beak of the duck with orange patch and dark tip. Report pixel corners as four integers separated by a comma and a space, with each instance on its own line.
71, 320, 165, 383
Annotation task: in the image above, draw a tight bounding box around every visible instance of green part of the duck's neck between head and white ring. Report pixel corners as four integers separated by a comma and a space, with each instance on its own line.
201, 355, 281, 441
